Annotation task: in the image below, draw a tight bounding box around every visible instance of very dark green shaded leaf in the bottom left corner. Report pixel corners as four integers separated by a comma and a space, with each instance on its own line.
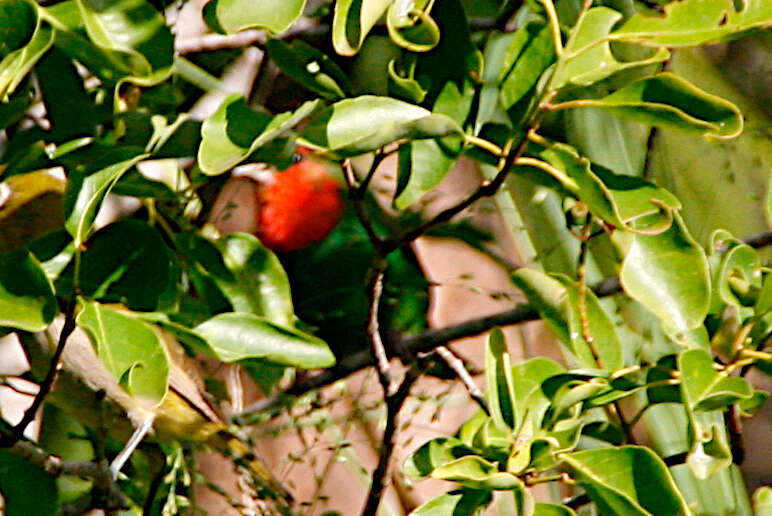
0, 449, 59, 516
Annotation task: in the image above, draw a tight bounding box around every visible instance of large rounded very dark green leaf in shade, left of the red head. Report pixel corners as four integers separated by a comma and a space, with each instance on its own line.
63, 219, 171, 311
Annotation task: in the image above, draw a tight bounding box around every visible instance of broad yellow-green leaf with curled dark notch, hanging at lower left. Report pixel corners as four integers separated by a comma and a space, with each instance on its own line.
76, 301, 169, 404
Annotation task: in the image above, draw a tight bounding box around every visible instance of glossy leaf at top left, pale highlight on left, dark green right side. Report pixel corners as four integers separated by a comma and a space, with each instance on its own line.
76, 0, 174, 77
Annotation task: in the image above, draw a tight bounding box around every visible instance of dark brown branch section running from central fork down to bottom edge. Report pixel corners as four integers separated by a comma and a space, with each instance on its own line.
362, 362, 421, 516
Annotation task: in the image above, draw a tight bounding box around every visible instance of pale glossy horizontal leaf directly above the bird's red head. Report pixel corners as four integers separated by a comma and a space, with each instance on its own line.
302, 95, 463, 156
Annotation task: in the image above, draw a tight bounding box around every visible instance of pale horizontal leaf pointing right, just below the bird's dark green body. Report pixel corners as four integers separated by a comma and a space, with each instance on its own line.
194, 312, 335, 369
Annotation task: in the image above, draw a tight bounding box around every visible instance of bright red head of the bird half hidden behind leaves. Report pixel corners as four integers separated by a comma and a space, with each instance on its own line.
257, 159, 345, 252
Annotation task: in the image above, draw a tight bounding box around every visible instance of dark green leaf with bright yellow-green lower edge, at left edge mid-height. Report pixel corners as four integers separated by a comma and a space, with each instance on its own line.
0, 249, 58, 331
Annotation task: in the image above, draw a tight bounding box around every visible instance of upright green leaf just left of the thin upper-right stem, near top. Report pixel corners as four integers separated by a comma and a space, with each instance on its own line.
499, 23, 555, 110
